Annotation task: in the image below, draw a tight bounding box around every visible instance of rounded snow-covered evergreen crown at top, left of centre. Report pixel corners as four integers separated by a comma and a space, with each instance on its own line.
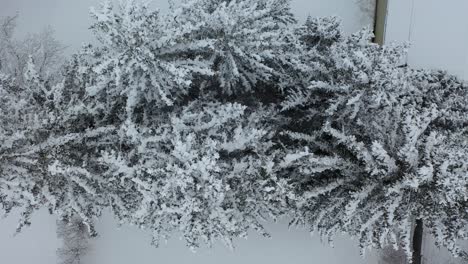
87, 1, 211, 111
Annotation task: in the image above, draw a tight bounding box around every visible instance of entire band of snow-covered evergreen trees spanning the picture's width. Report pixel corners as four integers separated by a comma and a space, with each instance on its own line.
0, 0, 468, 260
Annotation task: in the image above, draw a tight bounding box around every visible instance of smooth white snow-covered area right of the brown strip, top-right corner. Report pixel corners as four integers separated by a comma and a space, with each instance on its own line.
386, 0, 468, 79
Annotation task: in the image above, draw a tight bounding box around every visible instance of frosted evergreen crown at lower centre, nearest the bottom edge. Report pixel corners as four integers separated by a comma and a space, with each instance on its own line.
96, 102, 288, 249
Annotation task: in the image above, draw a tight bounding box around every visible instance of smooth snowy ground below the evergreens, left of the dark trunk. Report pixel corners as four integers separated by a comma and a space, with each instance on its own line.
0, 210, 377, 264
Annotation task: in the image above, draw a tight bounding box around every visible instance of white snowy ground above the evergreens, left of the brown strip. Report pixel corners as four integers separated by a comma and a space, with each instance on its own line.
0, 0, 374, 54
